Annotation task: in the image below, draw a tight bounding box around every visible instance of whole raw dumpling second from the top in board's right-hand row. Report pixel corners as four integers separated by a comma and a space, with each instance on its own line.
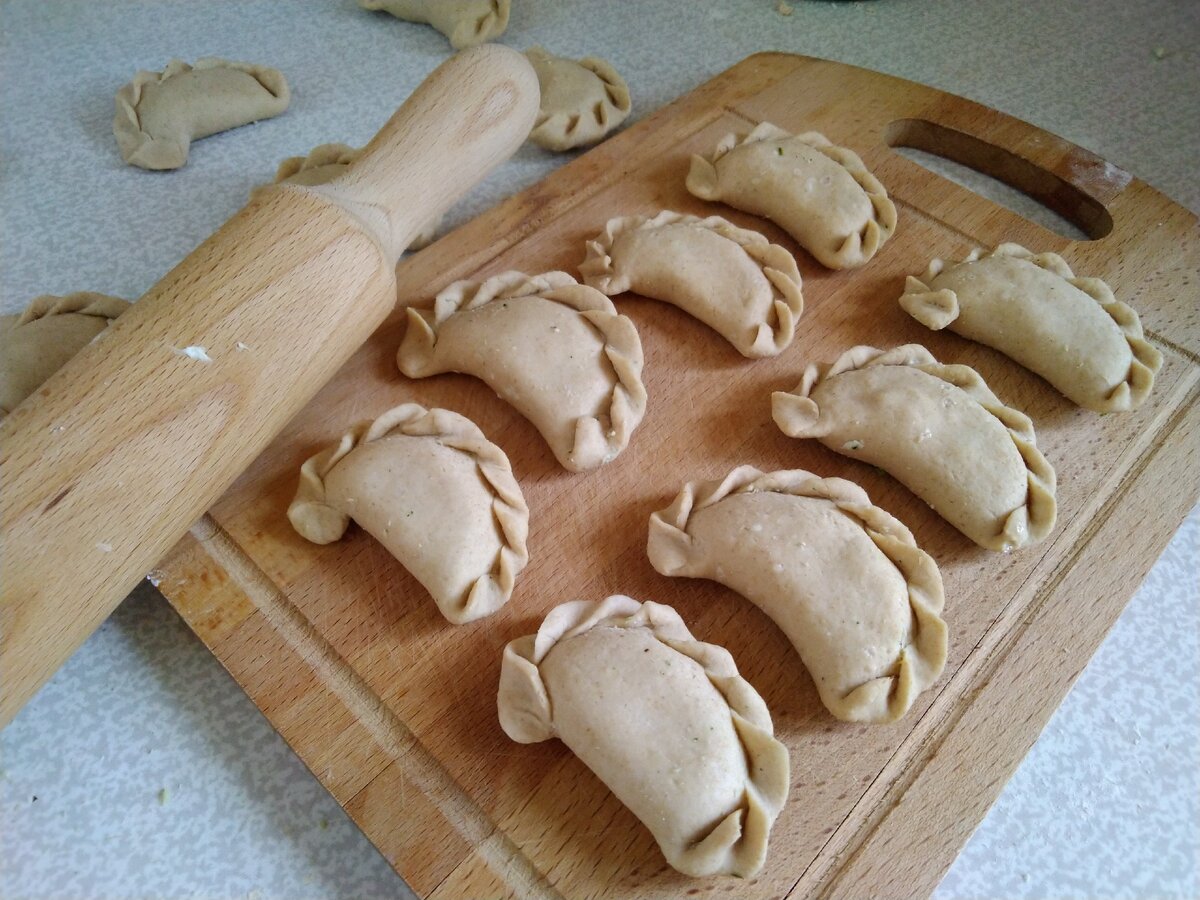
770, 344, 1057, 552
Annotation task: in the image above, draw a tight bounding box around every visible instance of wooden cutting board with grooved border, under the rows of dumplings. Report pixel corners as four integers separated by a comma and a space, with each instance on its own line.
154, 54, 1200, 898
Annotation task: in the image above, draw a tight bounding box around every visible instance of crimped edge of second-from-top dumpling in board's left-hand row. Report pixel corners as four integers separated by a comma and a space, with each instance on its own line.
580, 210, 804, 356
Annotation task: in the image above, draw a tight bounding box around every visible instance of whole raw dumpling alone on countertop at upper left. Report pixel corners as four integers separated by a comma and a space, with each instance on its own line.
113, 56, 290, 169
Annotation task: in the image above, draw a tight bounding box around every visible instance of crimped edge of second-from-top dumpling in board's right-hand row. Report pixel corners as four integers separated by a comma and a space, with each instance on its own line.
770, 343, 1058, 552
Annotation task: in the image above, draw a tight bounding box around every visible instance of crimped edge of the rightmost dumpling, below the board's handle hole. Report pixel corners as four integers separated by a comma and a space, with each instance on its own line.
900, 244, 1163, 413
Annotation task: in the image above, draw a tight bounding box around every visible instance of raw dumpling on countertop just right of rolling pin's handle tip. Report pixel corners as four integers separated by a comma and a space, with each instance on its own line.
526, 47, 632, 150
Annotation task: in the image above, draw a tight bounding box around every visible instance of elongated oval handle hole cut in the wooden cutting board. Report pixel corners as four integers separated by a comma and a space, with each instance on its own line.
883, 119, 1112, 241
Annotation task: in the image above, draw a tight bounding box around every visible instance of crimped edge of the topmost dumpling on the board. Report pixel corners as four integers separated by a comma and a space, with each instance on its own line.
686, 122, 896, 269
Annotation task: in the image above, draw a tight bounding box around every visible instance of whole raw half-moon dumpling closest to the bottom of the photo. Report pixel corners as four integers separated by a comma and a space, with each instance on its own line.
498, 595, 790, 877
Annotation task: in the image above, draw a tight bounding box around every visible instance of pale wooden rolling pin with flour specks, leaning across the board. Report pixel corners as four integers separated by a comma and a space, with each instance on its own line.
0, 44, 539, 727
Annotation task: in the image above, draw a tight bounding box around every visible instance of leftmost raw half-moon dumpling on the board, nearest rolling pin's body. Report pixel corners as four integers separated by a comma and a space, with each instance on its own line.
288, 403, 529, 625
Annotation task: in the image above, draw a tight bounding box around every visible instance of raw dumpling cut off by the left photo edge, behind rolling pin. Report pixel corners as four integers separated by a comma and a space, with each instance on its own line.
0, 292, 130, 419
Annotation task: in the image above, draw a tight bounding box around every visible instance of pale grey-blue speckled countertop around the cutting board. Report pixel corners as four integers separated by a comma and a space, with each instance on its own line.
0, 0, 1200, 898
